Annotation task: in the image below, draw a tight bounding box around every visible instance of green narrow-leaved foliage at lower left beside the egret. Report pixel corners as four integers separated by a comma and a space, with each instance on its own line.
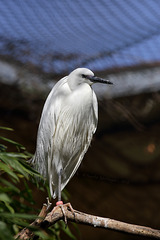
0, 127, 75, 240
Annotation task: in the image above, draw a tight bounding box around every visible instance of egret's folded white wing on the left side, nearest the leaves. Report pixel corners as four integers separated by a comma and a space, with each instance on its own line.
31, 77, 67, 178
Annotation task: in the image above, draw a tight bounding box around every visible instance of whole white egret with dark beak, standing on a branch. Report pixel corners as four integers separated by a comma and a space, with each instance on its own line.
32, 68, 112, 205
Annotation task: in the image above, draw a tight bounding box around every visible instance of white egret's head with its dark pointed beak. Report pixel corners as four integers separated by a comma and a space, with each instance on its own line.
68, 68, 112, 89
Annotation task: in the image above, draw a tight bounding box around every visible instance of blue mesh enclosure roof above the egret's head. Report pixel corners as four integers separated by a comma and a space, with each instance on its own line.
0, 0, 160, 73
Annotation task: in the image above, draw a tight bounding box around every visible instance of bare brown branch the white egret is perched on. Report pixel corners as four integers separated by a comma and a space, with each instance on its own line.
15, 204, 160, 240
